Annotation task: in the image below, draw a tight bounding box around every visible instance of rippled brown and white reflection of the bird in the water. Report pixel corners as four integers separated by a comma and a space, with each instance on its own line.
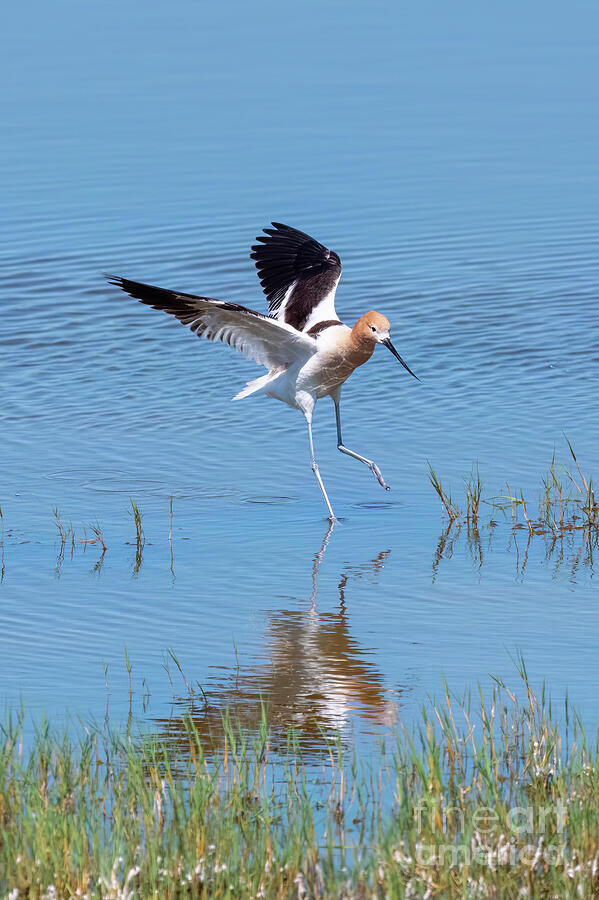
152, 523, 402, 753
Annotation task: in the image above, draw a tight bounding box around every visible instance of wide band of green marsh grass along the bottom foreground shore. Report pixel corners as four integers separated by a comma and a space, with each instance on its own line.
0, 665, 599, 900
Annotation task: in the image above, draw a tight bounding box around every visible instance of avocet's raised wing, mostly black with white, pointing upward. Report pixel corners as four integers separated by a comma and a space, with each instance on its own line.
250, 222, 341, 332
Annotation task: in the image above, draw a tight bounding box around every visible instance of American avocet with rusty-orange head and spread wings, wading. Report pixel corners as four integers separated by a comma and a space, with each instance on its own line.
108, 222, 417, 521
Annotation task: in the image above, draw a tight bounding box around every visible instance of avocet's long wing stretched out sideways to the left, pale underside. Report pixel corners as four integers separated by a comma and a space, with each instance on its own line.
107, 275, 317, 370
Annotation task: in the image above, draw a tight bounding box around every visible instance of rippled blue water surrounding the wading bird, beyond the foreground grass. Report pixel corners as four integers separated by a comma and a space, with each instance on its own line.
0, 0, 599, 747
